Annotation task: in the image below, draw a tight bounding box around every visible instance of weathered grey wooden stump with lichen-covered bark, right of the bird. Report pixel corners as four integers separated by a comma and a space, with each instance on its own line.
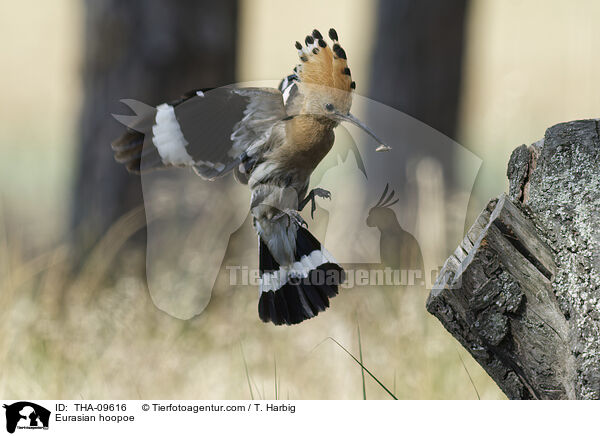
427, 120, 600, 399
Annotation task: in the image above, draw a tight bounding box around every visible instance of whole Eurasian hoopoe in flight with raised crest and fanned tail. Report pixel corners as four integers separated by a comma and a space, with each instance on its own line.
112, 29, 389, 325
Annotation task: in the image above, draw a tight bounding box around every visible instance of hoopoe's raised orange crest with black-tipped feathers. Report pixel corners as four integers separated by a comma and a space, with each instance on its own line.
296, 29, 356, 112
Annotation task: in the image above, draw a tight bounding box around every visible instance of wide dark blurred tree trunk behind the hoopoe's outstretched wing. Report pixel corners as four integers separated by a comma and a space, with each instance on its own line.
72, 0, 238, 249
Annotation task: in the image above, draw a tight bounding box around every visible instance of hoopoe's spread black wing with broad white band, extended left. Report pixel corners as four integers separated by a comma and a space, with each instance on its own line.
112, 86, 286, 179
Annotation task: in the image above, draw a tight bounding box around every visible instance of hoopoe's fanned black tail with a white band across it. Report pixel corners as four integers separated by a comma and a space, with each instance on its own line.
258, 227, 345, 325
